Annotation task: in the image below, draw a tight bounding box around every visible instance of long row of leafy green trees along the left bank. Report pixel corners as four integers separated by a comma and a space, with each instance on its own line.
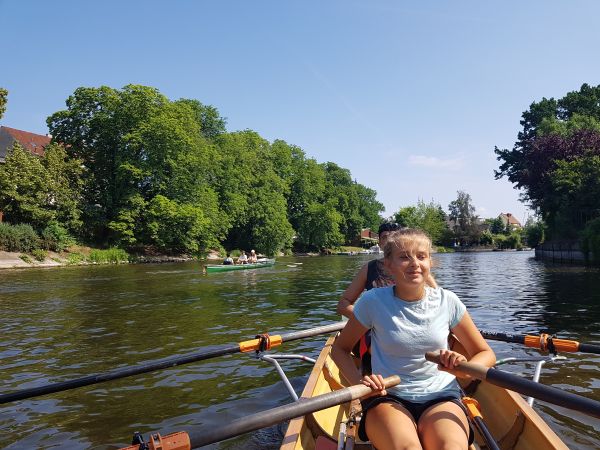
0, 85, 383, 254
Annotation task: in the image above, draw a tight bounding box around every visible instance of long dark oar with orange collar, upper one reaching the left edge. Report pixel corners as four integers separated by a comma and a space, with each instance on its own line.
0, 322, 345, 404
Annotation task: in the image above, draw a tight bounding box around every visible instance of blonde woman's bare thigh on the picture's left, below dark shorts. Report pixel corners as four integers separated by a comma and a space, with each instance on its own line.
365, 403, 422, 450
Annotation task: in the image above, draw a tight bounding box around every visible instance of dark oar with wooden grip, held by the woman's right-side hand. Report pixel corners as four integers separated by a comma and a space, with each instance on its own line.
425, 352, 600, 419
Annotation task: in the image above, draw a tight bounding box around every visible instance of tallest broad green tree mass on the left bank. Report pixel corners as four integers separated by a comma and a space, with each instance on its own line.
48, 85, 228, 250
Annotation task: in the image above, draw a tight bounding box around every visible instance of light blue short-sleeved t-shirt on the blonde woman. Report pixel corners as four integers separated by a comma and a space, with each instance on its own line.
354, 286, 466, 402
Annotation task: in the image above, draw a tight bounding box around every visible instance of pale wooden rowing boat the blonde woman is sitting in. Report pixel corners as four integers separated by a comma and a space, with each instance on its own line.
281, 336, 568, 450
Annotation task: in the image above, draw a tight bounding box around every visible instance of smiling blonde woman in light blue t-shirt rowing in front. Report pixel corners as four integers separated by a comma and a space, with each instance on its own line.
332, 229, 496, 450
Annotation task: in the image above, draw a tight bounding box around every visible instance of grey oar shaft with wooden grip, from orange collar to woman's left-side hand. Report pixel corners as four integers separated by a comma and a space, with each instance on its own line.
188, 375, 400, 448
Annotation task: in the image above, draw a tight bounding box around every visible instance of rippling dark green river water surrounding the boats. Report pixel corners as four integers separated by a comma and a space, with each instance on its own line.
0, 252, 600, 449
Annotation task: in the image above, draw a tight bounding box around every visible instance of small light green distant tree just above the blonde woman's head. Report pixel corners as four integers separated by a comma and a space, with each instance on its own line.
394, 200, 448, 244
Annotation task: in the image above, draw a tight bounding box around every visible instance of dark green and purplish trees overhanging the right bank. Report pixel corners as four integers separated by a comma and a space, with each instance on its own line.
495, 84, 600, 259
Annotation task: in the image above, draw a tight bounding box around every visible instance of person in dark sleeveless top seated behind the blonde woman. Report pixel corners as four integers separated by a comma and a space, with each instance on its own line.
337, 222, 401, 373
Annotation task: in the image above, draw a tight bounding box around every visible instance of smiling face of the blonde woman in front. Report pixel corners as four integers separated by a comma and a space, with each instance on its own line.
385, 243, 431, 287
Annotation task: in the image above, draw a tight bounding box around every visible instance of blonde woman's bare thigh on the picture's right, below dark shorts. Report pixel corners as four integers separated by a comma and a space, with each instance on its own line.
418, 402, 470, 450
